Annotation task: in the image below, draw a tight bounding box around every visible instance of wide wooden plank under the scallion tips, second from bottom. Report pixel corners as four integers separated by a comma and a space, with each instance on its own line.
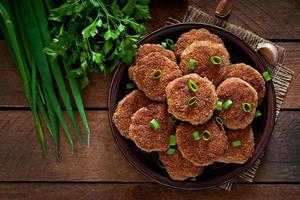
0, 111, 300, 182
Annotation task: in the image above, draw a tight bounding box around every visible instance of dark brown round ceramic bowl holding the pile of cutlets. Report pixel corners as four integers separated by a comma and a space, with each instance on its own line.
108, 23, 276, 189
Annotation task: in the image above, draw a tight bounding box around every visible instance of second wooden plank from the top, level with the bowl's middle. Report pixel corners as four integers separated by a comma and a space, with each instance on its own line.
0, 40, 300, 109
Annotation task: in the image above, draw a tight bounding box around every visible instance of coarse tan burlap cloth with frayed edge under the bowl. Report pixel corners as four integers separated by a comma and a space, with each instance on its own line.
166, 6, 294, 191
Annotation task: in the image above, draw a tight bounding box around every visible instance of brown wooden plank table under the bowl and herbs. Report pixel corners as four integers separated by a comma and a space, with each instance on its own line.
0, 0, 300, 200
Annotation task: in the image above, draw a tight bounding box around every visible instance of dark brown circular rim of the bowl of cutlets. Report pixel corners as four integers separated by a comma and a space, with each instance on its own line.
107, 22, 276, 190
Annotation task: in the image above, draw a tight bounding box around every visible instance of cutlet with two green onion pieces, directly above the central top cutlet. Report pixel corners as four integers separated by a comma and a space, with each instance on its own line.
179, 41, 230, 85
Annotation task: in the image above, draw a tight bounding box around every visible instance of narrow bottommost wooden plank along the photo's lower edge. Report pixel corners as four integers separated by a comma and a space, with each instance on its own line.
0, 183, 300, 200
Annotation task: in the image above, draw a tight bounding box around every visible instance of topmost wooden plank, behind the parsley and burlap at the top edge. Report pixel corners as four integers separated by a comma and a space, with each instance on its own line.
147, 0, 300, 39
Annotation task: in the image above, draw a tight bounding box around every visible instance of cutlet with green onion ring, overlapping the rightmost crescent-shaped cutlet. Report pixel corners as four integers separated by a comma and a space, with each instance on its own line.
217, 78, 258, 130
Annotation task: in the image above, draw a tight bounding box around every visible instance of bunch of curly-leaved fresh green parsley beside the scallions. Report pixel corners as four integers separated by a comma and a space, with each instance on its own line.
45, 0, 150, 88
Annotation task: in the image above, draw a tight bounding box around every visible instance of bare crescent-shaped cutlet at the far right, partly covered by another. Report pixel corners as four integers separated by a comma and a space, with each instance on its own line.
225, 63, 266, 105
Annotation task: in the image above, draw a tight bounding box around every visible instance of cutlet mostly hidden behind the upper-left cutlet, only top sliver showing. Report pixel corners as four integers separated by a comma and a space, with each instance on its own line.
135, 44, 176, 62
